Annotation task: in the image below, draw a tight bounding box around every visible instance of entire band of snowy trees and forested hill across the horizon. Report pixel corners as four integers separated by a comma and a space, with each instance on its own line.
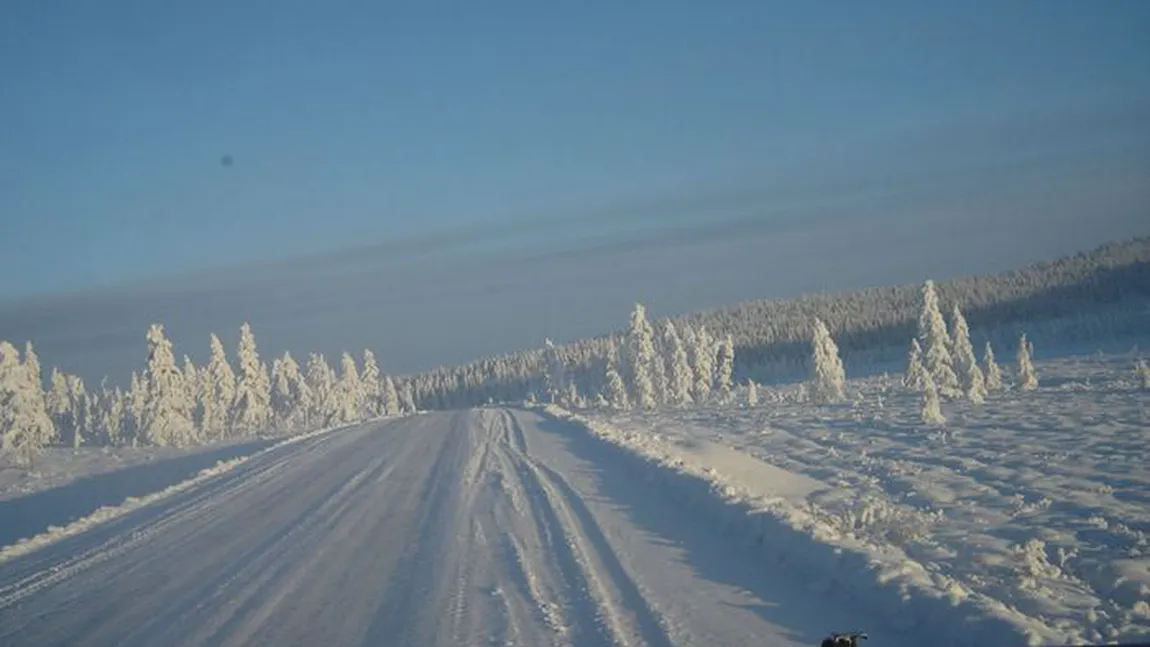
0, 238, 1150, 464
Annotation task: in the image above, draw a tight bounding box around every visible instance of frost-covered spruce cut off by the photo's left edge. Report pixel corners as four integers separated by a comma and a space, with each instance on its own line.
0, 341, 55, 468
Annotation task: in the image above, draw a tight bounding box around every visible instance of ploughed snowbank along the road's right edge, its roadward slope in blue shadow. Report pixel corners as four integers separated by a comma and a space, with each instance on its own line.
547, 407, 1055, 646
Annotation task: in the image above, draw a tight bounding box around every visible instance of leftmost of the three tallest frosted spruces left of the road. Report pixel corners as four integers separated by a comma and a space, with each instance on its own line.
140, 323, 197, 447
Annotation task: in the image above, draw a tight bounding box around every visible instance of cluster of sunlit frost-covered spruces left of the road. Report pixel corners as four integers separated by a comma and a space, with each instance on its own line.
0, 323, 415, 465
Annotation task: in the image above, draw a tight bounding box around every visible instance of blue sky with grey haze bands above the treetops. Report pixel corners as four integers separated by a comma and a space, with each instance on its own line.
0, 0, 1150, 381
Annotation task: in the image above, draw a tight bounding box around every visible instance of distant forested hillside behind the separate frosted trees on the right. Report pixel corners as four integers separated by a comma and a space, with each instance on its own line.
409, 237, 1150, 408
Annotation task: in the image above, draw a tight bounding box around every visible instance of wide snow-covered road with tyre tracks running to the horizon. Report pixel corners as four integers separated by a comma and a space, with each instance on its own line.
0, 409, 894, 647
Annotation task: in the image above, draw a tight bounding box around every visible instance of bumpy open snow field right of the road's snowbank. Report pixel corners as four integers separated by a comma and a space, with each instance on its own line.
565, 354, 1150, 641
